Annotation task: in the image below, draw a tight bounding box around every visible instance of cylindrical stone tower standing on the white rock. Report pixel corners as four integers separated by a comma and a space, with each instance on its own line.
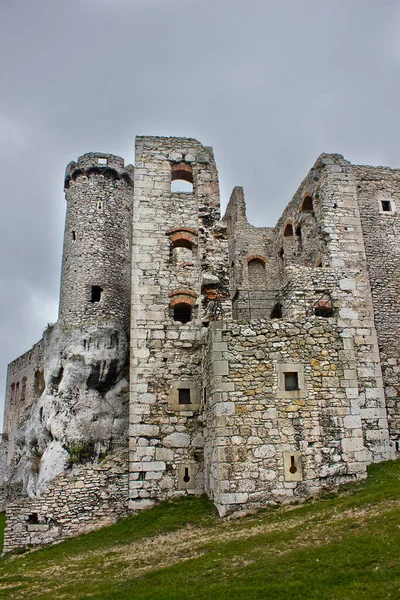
59, 153, 134, 332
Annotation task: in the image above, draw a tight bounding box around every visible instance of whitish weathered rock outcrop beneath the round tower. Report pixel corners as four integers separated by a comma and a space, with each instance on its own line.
3, 324, 129, 496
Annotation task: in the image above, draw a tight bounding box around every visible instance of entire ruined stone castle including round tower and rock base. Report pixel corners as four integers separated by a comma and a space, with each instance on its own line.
0, 136, 400, 550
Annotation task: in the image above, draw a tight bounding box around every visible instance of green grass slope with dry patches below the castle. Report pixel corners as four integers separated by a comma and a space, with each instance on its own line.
0, 461, 400, 600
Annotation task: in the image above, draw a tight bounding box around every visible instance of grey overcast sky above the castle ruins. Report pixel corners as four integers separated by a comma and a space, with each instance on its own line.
0, 0, 400, 426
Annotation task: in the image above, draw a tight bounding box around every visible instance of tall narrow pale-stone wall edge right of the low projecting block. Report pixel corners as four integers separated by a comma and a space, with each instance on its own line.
317, 155, 394, 462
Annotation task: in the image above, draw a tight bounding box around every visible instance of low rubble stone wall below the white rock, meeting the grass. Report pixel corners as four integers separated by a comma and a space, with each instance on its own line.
4, 453, 128, 552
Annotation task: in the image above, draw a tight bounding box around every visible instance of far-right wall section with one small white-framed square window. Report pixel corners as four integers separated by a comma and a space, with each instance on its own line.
353, 166, 400, 440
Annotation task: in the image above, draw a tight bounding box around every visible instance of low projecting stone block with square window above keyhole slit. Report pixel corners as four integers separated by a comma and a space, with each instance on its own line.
205, 317, 369, 515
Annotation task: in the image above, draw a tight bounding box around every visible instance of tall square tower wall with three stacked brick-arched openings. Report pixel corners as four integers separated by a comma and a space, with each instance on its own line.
130, 137, 228, 510
